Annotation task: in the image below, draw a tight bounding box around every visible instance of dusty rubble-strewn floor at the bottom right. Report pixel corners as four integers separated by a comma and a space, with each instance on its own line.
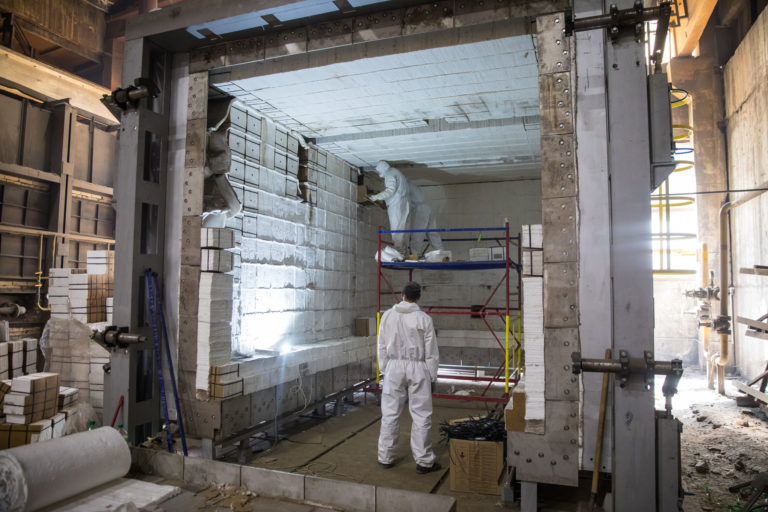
672, 368, 768, 512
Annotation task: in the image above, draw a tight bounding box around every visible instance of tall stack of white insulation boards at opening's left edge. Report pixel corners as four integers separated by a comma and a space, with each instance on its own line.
195, 228, 234, 399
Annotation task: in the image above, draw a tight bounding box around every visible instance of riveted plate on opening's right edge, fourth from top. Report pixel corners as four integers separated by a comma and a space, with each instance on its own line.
542, 197, 579, 263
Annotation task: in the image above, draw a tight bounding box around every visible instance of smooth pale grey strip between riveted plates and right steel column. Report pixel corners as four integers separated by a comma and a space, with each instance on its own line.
574, 12, 613, 472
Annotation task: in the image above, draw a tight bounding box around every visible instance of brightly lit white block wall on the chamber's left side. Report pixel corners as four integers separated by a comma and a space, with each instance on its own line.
222, 103, 386, 354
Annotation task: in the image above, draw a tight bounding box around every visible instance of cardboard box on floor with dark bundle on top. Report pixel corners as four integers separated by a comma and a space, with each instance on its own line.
450, 439, 504, 494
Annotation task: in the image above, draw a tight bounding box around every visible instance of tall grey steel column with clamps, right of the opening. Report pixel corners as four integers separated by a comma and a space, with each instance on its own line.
605, 0, 656, 512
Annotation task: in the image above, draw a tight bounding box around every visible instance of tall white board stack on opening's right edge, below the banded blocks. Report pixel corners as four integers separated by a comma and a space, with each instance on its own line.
523, 277, 544, 434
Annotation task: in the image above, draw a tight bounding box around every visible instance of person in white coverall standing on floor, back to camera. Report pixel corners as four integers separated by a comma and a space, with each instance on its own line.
378, 282, 440, 473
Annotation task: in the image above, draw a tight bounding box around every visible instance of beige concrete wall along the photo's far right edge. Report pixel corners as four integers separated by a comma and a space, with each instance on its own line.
725, 6, 768, 377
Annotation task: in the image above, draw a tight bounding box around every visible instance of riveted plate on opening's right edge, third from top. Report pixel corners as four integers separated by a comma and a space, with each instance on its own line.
541, 134, 578, 199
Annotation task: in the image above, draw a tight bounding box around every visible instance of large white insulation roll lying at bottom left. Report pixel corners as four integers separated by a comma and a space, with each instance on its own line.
0, 427, 131, 512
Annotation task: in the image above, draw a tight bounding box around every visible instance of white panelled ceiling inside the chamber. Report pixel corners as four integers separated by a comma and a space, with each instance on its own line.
217, 36, 540, 184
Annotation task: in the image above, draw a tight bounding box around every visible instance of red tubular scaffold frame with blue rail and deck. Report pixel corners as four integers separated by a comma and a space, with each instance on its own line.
366, 221, 522, 403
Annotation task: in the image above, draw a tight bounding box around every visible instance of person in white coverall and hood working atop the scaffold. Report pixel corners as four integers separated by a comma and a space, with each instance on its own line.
369, 160, 443, 259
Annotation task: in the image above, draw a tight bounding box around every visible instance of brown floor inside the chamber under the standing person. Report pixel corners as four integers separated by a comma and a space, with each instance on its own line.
219, 394, 592, 512
